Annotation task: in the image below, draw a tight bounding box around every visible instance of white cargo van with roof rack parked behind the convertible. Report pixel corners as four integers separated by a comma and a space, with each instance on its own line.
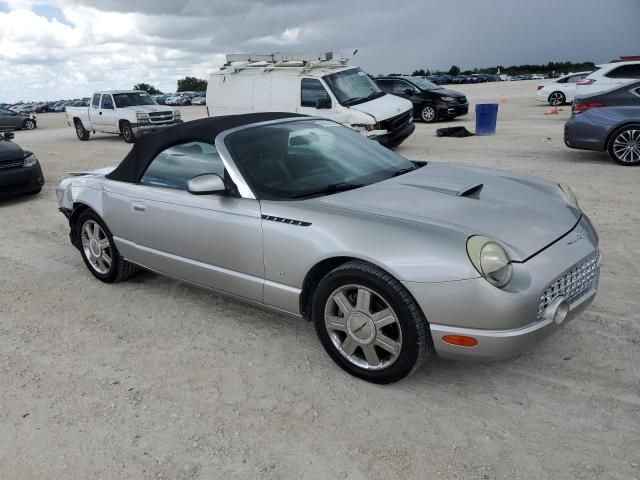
207, 53, 415, 147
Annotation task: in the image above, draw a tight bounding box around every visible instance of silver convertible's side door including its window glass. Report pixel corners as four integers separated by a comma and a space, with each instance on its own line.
104, 142, 264, 301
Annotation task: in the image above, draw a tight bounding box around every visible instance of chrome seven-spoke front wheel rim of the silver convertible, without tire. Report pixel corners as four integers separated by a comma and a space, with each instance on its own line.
324, 285, 402, 370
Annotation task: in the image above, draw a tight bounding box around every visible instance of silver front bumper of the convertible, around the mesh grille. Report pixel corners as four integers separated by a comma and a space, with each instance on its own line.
403, 215, 599, 360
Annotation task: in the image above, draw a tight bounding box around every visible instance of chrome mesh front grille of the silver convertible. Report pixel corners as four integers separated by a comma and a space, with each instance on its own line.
538, 252, 600, 320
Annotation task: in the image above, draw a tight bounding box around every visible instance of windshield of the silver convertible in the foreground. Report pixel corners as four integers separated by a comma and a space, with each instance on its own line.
225, 120, 421, 200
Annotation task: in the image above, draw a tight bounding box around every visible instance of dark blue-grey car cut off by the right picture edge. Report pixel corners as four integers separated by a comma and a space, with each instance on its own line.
564, 81, 640, 166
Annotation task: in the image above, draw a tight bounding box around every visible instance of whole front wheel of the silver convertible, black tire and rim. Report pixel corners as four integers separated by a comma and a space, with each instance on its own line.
312, 261, 433, 384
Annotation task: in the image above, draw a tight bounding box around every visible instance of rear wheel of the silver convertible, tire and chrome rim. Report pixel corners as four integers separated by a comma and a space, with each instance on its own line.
75, 210, 139, 283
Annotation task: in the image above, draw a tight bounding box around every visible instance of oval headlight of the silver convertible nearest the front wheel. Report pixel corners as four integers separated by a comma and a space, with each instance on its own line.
467, 235, 513, 288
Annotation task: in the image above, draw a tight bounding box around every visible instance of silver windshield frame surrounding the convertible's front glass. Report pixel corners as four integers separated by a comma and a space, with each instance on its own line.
220, 116, 426, 202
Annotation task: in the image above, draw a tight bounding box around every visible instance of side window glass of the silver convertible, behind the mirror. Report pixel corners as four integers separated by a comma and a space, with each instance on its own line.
140, 142, 225, 191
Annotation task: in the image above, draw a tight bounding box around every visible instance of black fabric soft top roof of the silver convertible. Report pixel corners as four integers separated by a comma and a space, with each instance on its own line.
106, 112, 305, 183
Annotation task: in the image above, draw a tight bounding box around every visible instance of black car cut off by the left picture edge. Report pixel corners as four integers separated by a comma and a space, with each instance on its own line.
0, 132, 44, 197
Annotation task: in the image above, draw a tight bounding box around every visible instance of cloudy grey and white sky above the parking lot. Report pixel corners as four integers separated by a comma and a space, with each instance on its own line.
0, 0, 640, 102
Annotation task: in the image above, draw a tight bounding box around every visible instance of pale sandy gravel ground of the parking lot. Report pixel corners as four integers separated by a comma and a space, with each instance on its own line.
0, 82, 640, 480
